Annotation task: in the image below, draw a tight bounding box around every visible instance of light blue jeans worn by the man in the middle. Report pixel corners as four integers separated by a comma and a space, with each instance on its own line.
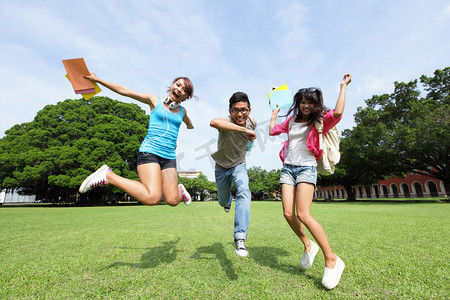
215, 163, 251, 240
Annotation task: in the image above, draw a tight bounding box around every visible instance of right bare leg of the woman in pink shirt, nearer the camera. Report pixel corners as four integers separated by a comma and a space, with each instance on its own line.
295, 182, 336, 268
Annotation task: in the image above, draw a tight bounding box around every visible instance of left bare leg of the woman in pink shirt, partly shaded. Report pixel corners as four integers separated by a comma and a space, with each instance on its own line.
281, 184, 311, 252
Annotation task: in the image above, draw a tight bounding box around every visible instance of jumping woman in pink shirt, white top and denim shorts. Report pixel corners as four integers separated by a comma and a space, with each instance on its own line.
269, 74, 352, 289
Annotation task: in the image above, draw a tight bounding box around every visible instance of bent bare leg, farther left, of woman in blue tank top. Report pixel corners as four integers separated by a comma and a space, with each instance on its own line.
106, 163, 162, 205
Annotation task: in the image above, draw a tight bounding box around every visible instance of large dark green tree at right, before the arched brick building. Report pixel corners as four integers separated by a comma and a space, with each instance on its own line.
329, 68, 450, 198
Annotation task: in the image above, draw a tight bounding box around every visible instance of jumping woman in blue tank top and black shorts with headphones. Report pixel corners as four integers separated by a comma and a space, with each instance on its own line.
79, 73, 194, 206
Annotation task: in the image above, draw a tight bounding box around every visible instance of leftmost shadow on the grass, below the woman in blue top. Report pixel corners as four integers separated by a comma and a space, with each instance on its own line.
105, 238, 180, 269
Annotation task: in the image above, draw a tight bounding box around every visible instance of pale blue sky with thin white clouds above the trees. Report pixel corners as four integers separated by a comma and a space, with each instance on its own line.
0, 0, 450, 181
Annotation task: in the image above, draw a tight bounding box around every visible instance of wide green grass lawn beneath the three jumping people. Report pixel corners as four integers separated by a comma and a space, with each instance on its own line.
0, 201, 450, 299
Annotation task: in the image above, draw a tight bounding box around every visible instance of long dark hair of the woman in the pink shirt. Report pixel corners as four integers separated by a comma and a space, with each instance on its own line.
285, 88, 328, 125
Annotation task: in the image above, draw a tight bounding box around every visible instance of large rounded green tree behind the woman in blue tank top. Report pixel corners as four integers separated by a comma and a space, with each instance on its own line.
0, 97, 148, 200
